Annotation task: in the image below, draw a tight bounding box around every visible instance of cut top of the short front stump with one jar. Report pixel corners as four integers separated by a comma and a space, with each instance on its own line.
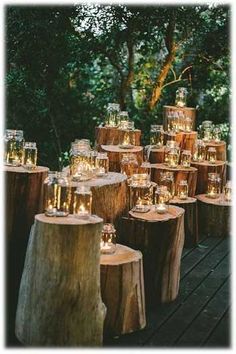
100, 244, 142, 265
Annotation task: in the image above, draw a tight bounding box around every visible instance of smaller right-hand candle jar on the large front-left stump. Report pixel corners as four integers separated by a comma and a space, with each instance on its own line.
73, 186, 92, 219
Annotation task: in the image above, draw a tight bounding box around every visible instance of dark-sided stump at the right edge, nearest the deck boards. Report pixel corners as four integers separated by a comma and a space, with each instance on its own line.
196, 194, 232, 237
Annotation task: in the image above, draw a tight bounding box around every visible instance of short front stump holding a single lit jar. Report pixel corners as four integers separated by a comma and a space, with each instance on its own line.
100, 244, 146, 336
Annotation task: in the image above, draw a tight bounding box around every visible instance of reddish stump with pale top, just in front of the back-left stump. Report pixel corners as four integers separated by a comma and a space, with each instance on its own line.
101, 145, 143, 172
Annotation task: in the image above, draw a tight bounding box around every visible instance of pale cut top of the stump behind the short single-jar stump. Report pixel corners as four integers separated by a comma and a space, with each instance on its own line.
129, 205, 185, 222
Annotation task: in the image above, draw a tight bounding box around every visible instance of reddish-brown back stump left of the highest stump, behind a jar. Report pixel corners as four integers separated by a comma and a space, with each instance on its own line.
95, 127, 141, 149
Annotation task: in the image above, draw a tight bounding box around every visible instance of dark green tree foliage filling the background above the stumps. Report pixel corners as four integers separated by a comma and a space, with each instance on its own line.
6, 5, 230, 169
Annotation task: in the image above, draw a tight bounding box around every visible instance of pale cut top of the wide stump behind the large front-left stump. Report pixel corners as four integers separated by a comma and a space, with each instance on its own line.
68, 172, 127, 187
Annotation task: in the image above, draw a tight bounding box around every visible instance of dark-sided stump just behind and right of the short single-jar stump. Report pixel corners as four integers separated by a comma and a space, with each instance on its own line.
118, 205, 184, 307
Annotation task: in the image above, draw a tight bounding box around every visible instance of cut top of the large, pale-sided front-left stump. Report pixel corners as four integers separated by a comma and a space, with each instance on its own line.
35, 214, 103, 225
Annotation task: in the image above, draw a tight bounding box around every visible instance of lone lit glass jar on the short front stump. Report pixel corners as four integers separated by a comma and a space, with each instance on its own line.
100, 223, 116, 254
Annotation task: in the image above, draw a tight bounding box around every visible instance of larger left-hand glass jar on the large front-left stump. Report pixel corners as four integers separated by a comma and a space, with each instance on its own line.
44, 171, 71, 217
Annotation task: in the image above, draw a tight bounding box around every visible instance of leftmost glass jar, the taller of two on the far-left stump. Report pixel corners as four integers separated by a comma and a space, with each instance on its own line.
4, 129, 24, 166
